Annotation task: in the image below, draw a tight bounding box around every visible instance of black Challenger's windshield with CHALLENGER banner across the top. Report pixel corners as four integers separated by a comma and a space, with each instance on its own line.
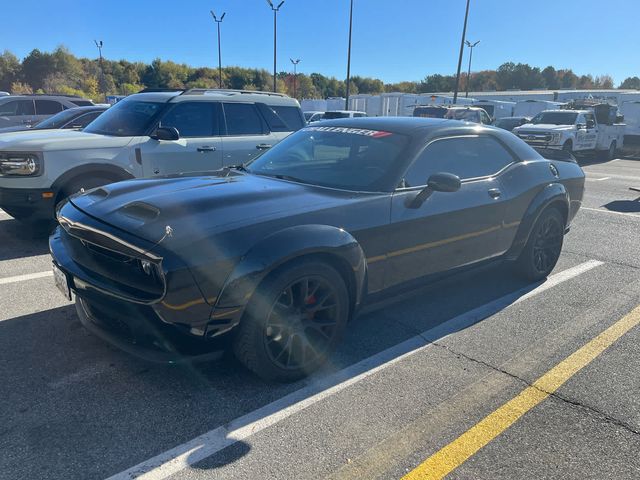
247, 127, 408, 191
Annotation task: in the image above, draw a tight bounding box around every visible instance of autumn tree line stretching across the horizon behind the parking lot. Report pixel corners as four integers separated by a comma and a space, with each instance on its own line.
0, 46, 640, 101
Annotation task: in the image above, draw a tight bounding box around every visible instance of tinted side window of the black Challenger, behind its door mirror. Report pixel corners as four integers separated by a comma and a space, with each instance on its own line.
404, 136, 515, 187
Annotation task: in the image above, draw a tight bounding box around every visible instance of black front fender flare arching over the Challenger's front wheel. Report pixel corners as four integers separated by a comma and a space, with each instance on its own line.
214, 225, 367, 311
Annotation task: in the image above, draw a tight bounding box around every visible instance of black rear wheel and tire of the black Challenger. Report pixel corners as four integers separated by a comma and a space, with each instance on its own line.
515, 207, 565, 281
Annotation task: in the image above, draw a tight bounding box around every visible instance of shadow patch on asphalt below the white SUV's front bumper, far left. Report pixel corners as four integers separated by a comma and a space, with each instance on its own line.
0, 219, 49, 261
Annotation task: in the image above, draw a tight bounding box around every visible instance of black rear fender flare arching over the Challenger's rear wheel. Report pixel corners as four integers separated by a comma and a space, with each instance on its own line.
506, 183, 570, 260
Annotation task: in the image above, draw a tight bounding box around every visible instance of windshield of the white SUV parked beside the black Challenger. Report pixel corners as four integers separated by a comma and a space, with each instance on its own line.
84, 99, 166, 137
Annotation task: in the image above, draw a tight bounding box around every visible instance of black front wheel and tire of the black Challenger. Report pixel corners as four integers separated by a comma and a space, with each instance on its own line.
233, 259, 349, 382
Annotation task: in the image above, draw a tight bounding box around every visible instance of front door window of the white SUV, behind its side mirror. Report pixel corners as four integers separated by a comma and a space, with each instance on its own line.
160, 102, 218, 138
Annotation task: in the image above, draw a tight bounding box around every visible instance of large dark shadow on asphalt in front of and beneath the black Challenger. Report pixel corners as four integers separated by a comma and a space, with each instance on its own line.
0, 266, 539, 479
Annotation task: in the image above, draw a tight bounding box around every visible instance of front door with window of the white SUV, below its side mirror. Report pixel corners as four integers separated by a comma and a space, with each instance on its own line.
139, 101, 222, 176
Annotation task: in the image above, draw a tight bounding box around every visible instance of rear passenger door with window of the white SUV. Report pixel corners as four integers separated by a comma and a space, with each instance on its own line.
222, 102, 279, 165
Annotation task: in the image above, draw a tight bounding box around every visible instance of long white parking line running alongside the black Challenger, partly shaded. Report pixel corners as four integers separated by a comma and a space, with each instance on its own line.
107, 260, 603, 480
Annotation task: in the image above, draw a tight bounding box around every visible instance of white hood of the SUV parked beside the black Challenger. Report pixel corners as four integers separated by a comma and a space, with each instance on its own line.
0, 130, 132, 151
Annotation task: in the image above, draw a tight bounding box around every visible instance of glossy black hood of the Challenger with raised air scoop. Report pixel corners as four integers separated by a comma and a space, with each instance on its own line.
70, 170, 358, 247
